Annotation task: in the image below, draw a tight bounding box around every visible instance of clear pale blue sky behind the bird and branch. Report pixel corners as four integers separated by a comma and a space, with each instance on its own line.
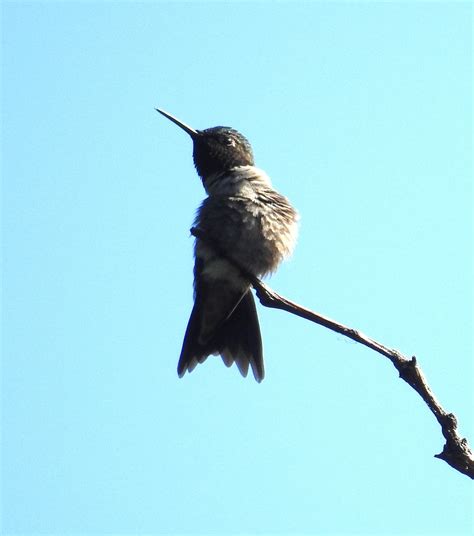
2, 2, 474, 535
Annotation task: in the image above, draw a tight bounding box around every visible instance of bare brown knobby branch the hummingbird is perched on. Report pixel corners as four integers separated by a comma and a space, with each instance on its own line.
191, 227, 474, 479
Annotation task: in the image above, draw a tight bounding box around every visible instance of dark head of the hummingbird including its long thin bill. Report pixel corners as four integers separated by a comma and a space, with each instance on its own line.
156, 108, 254, 180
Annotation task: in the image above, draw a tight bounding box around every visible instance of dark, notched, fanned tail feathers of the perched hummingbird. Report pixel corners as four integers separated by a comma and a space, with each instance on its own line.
178, 290, 265, 383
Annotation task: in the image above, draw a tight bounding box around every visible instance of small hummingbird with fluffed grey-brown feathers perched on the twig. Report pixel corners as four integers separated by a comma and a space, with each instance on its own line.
155, 108, 298, 383
